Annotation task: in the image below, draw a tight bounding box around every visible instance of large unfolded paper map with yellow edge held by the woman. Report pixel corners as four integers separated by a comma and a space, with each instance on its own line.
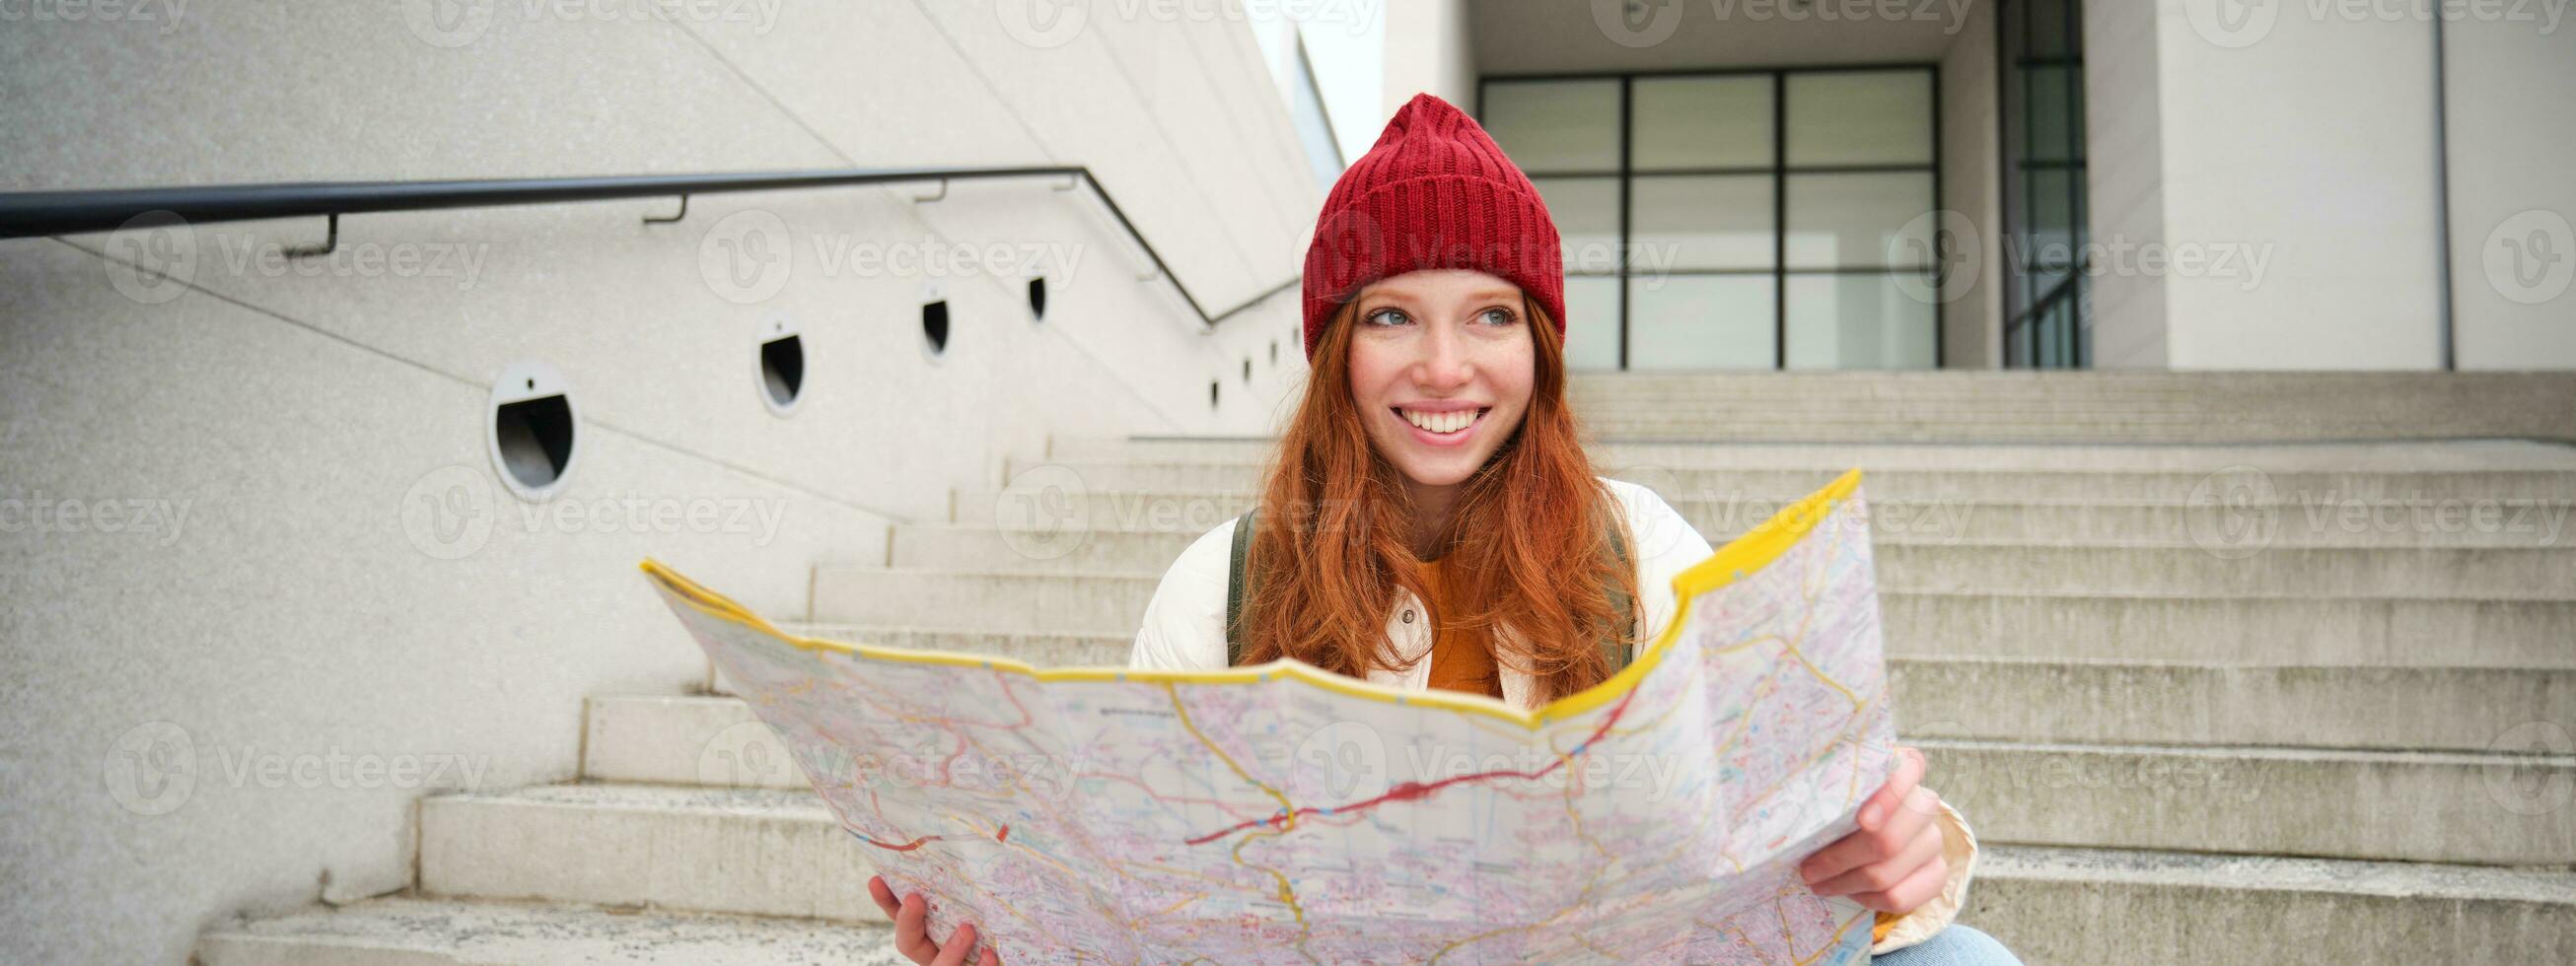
644, 471, 1896, 963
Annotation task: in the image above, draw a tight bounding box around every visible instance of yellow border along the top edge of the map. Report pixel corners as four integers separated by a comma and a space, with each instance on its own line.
641, 469, 1860, 731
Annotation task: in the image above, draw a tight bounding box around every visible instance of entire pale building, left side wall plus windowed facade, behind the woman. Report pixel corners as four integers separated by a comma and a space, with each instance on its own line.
0, 0, 2576, 963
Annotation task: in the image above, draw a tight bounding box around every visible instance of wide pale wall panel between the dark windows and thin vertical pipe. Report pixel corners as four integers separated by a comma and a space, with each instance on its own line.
2143, 0, 2442, 369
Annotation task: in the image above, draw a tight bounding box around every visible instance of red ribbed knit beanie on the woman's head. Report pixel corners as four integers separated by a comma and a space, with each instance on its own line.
1306, 93, 1566, 361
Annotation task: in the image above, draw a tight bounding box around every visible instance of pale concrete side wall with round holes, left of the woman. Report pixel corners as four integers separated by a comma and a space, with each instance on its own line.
0, 3, 1319, 963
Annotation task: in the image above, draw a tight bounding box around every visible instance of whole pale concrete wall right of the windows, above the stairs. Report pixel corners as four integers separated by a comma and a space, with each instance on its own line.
2084, 0, 2576, 369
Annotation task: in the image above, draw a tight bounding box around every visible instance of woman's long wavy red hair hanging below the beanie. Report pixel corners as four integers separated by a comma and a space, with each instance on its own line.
1245, 299, 1636, 701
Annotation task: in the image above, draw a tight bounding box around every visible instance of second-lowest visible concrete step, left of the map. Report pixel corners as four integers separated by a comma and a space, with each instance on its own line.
420, 783, 887, 923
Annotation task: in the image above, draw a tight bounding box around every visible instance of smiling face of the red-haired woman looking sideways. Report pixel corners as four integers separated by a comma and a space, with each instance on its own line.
1350, 268, 1538, 505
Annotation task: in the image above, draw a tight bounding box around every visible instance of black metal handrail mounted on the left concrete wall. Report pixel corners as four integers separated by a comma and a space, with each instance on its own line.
0, 165, 1298, 327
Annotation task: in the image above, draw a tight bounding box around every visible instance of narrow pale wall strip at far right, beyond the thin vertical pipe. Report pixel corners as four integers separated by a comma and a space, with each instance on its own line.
2442, 15, 2576, 369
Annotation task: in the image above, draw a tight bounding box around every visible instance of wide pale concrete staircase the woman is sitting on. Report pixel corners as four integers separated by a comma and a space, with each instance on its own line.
198, 374, 2576, 966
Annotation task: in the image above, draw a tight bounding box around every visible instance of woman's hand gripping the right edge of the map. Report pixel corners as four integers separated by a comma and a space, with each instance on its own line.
1798, 747, 1950, 915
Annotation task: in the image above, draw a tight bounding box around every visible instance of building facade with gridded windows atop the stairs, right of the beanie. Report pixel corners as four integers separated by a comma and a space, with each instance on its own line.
1349, 0, 2576, 371
